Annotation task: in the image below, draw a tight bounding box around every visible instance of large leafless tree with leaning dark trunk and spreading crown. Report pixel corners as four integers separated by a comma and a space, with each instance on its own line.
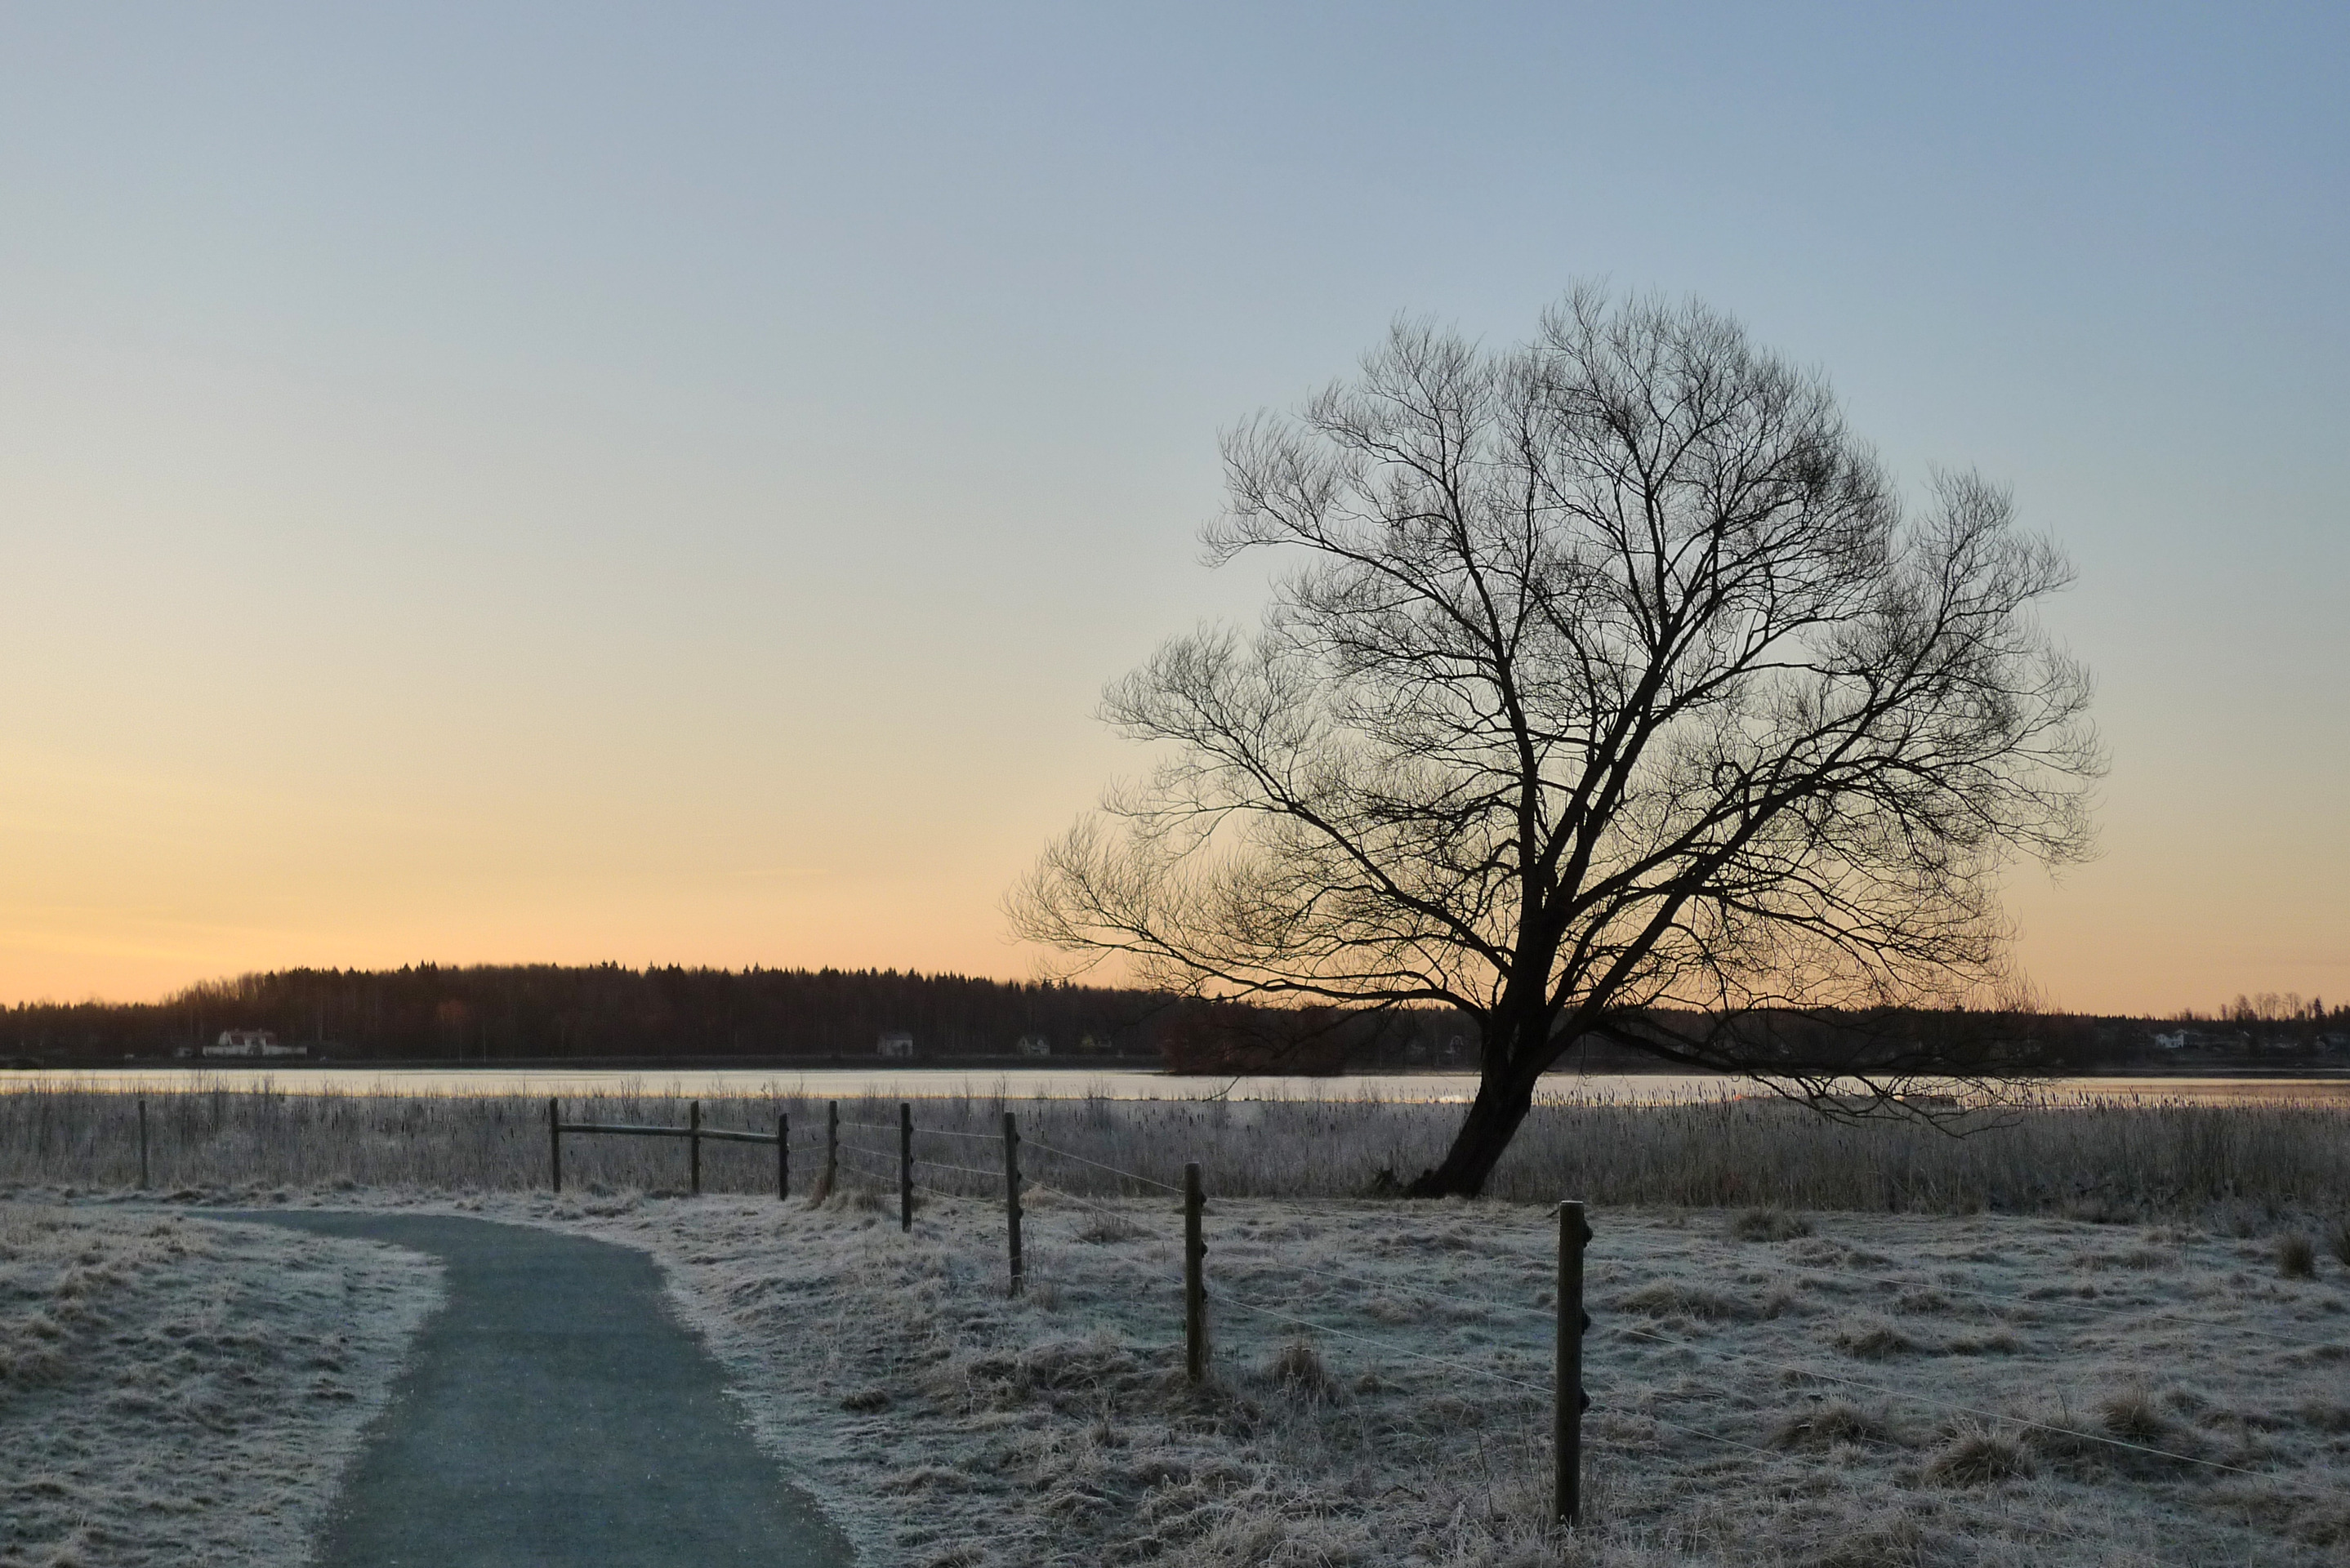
1008, 289, 2101, 1196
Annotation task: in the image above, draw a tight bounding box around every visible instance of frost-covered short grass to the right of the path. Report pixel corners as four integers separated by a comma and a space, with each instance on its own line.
100, 1183, 2350, 1568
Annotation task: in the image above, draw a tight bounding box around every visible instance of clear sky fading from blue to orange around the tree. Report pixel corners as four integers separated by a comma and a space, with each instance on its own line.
0, 0, 2350, 1013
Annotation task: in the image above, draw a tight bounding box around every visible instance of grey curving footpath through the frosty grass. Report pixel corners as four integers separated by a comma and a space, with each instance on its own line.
202, 1210, 855, 1568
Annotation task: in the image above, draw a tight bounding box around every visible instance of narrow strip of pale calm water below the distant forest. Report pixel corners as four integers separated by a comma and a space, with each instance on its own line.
0, 1065, 2350, 1107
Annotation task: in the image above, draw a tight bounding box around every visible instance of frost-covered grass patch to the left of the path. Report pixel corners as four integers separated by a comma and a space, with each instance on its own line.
0, 1194, 439, 1568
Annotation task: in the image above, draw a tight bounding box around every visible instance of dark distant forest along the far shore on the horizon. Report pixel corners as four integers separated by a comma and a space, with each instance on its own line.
0, 964, 2350, 1072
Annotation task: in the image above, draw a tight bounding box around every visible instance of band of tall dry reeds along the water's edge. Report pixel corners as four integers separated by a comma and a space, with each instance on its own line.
0, 1086, 2350, 1220
